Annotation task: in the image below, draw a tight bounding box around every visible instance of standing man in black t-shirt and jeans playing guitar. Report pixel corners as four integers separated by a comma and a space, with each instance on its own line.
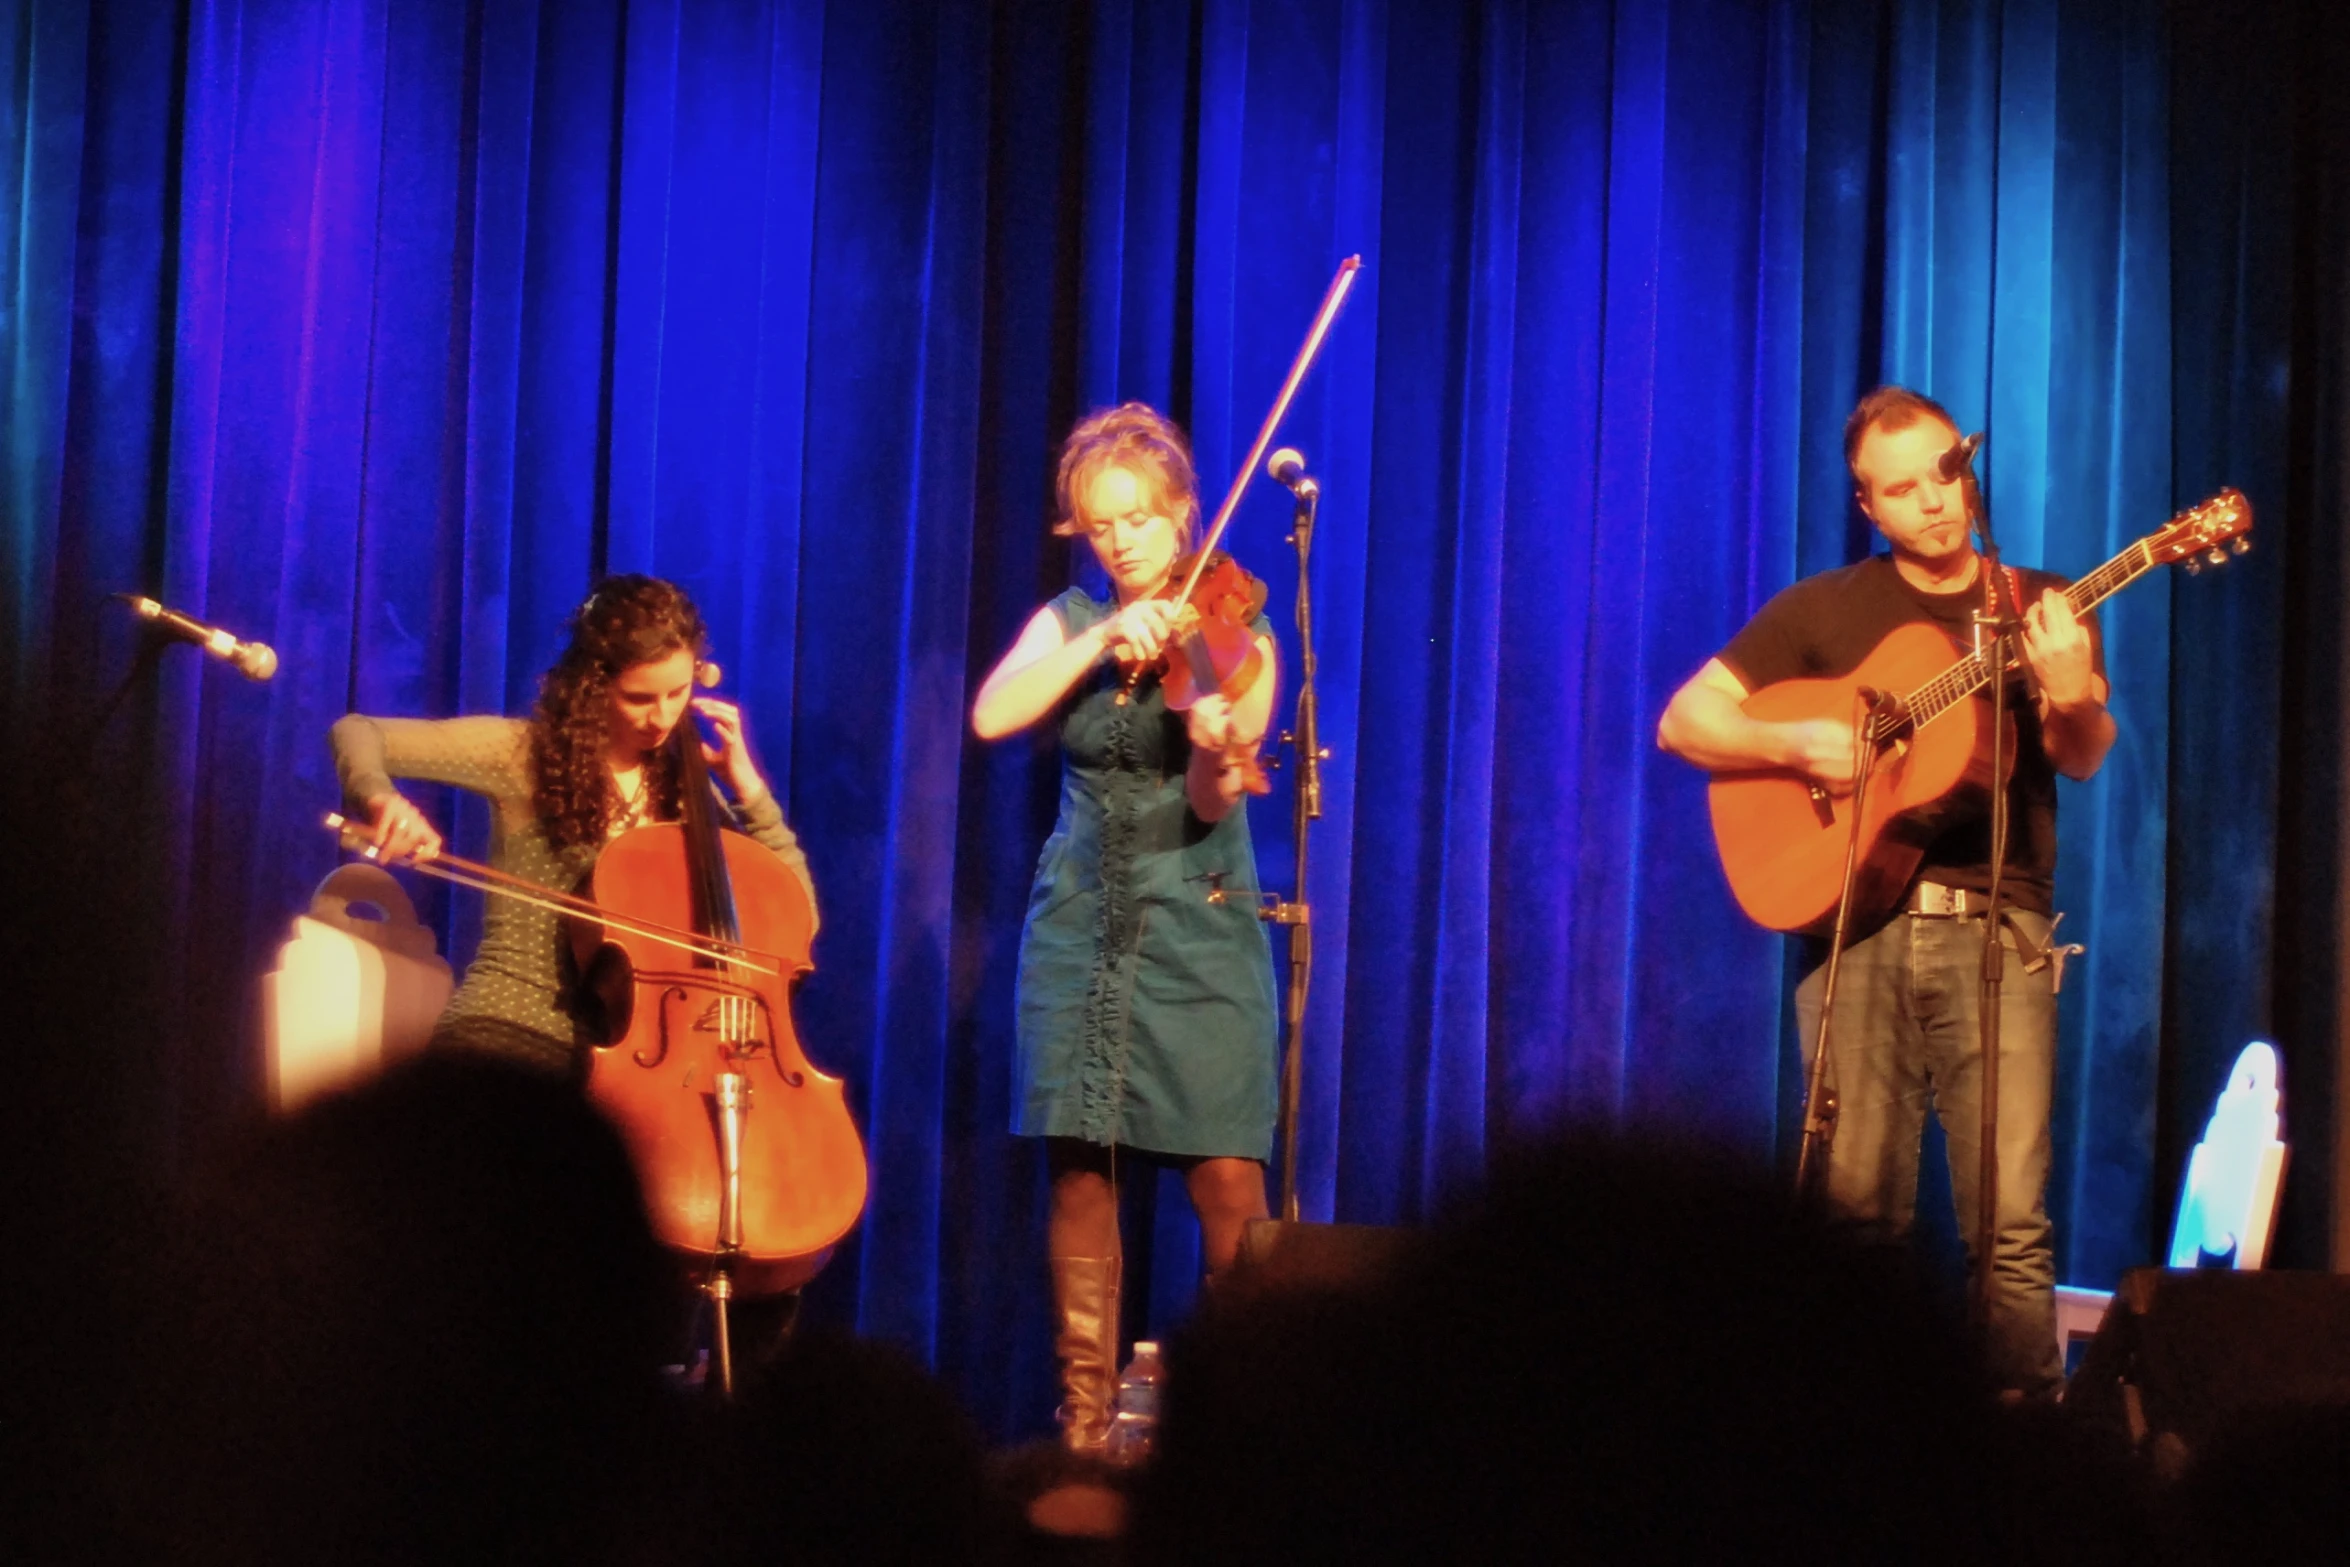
1657, 388, 2115, 1395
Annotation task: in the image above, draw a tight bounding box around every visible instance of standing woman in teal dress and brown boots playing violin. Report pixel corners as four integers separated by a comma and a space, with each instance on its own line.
971, 402, 1274, 1450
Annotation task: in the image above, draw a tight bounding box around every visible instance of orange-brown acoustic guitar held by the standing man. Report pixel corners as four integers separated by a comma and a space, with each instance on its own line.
1706, 489, 2251, 930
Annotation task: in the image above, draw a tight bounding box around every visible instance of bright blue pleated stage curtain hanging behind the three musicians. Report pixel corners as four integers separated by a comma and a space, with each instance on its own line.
0, 0, 2282, 1433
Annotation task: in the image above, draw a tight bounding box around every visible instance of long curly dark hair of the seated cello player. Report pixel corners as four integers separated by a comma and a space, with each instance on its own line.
531, 576, 710, 848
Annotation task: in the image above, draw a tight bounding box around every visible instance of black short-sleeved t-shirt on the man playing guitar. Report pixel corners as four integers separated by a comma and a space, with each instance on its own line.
1720, 554, 2106, 914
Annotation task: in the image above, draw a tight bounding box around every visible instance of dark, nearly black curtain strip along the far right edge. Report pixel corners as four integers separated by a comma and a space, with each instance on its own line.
2155, 0, 2350, 1271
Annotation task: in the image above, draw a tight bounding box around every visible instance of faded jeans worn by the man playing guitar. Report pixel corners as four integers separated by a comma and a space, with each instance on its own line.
1795, 909, 2063, 1395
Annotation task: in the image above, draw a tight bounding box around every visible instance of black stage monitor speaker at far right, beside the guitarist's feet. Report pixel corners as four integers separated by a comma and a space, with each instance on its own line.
2066, 1269, 2350, 1473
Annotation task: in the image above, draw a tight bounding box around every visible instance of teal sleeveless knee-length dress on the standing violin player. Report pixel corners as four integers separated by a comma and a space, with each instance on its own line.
1013, 587, 1274, 1161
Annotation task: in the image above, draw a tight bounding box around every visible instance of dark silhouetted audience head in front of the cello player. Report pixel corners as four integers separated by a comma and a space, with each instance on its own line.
139, 1052, 674, 1562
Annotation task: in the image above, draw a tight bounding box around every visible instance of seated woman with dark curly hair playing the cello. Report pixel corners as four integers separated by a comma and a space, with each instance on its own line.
334, 576, 815, 1071
